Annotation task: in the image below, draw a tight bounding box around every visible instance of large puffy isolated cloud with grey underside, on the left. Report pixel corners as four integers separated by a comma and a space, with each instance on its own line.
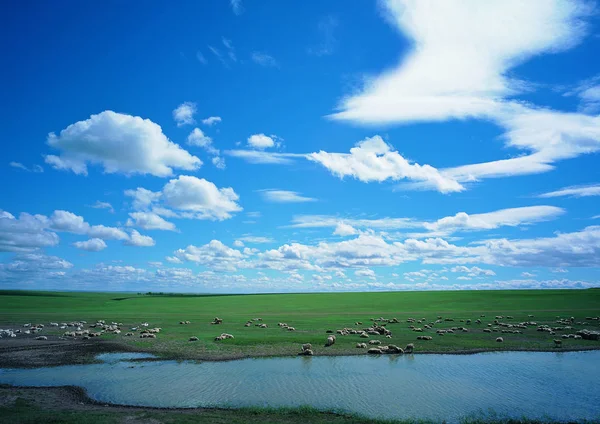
46, 110, 202, 177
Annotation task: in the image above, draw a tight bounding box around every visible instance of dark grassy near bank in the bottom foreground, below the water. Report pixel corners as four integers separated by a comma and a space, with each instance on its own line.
0, 385, 600, 424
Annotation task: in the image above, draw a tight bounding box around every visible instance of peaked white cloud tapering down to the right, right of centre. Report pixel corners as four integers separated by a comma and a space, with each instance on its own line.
307, 135, 464, 193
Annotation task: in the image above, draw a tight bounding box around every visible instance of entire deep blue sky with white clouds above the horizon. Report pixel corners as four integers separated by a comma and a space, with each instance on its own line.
0, 0, 600, 292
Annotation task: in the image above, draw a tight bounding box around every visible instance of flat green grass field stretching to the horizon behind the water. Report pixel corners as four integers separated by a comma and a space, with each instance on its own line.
0, 289, 600, 359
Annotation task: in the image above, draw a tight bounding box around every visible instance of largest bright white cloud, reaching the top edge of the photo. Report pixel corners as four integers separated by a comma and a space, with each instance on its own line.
333, 0, 589, 124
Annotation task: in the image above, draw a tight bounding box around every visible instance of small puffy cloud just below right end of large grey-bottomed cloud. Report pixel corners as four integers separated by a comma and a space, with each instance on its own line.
162, 175, 242, 221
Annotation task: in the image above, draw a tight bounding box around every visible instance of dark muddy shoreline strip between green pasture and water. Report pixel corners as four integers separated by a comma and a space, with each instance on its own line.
0, 338, 600, 368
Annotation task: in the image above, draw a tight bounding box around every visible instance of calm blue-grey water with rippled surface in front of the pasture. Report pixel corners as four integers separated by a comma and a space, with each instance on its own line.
0, 351, 600, 422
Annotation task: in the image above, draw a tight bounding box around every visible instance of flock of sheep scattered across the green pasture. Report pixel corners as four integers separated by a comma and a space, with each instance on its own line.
0, 315, 600, 356
